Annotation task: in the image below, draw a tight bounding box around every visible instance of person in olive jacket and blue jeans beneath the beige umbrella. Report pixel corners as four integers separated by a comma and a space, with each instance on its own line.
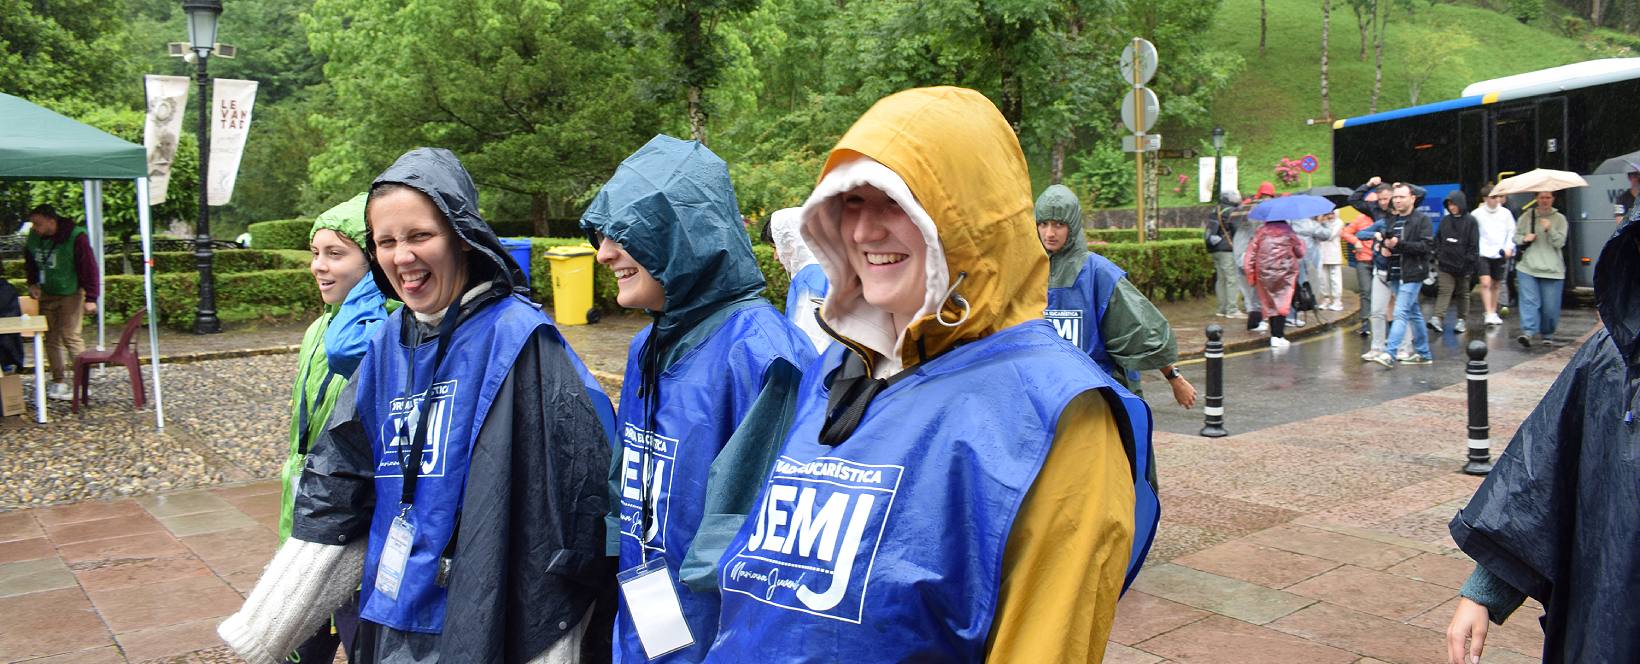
1515, 192, 1566, 348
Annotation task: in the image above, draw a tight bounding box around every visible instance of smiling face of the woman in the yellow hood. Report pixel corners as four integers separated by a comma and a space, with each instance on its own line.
841, 185, 928, 322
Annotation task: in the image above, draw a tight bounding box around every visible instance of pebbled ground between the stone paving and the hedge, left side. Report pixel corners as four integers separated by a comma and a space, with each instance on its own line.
0, 315, 649, 512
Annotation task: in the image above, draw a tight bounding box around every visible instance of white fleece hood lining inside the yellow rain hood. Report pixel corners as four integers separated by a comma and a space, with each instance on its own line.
800, 157, 950, 377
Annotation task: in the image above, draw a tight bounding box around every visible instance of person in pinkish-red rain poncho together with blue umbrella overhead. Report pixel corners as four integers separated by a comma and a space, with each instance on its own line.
1243, 195, 1333, 348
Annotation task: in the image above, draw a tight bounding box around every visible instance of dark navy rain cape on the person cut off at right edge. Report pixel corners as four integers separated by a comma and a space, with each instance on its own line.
1450, 209, 1640, 662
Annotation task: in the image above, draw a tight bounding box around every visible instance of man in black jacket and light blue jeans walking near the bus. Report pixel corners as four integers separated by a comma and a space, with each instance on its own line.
1373, 182, 1435, 369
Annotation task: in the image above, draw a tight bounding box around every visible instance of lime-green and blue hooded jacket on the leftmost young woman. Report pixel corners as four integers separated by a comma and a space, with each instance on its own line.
279, 193, 397, 541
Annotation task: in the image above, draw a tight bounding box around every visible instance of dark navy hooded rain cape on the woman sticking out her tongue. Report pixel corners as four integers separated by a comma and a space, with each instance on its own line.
290, 149, 613, 662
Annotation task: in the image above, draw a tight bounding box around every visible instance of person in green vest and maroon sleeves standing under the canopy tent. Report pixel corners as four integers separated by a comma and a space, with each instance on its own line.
23, 205, 102, 402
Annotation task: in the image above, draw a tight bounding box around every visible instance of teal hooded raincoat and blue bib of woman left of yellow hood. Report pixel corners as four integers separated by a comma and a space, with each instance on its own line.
581, 136, 813, 662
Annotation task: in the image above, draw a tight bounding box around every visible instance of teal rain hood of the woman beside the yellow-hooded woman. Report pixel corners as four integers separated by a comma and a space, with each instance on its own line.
581, 134, 766, 348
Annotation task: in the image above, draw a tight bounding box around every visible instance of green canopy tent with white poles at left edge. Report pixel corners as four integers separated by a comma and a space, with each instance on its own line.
0, 93, 166, 428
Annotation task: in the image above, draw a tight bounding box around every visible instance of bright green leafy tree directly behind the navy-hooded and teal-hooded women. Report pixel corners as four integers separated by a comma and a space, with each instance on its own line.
303, 0, 661, 233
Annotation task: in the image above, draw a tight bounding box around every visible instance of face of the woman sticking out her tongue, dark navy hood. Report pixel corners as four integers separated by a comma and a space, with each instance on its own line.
367, 189, 467, 315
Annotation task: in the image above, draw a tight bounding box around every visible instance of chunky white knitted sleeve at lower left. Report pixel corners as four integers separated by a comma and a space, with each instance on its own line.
216, 538, 367, 664
